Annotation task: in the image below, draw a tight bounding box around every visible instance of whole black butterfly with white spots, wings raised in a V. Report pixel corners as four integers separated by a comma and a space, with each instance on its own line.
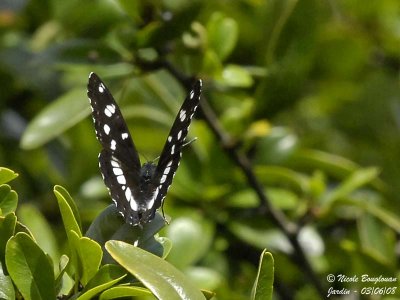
87, 73, 202, 227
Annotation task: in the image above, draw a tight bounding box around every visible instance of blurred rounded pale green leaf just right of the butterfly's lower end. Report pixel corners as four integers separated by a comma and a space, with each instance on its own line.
166, 217, 213, 270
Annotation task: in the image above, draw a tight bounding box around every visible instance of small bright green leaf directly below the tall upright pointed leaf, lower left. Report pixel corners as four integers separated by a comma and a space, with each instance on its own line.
69, 230, 103, 286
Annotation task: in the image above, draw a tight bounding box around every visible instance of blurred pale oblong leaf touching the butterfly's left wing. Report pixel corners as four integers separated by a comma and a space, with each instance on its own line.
21, 86, 90, 150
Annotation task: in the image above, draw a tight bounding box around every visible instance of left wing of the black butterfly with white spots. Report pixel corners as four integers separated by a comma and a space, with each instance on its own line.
87, 73, 141, 224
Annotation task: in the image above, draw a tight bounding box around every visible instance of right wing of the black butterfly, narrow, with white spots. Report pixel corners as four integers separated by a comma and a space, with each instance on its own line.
154, 80, 202, 209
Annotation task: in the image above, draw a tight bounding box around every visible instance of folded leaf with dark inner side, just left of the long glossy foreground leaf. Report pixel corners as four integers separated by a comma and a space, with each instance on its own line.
78, 265, 126, 300
